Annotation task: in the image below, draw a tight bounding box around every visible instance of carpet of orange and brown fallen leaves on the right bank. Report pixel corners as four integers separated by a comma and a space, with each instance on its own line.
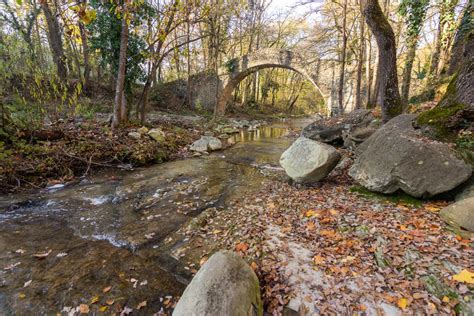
175, 180, 473, 314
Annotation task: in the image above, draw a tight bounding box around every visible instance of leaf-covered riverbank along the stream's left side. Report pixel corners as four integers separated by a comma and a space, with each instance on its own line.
0, 112, 288, 193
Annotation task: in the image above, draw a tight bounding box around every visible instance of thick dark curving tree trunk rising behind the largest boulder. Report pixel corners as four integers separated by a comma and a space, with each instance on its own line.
363, 0, 402, 122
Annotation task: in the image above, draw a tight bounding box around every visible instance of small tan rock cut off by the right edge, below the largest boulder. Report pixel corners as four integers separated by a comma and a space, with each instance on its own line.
439, 197, 474, 232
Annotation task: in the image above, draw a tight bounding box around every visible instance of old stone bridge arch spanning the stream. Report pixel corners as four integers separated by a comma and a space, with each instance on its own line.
214, 49, 331, 116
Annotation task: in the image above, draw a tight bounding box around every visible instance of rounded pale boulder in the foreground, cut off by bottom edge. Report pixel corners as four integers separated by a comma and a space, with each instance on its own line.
173, 251, 263, 316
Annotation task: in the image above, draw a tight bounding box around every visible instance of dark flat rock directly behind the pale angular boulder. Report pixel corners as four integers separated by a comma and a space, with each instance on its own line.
301, 110, 375, 144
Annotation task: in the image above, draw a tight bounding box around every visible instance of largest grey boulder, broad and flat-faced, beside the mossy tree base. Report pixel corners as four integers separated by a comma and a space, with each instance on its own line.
349, 114, 472, 197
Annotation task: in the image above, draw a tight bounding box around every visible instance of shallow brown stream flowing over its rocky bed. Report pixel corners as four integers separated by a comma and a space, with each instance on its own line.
0, 119, 310, 315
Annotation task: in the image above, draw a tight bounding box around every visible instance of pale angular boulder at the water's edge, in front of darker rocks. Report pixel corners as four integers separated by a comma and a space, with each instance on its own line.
280, 137, 341, 183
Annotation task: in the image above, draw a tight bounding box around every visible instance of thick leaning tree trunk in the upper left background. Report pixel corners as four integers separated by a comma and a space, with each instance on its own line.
40, 0, 67, 80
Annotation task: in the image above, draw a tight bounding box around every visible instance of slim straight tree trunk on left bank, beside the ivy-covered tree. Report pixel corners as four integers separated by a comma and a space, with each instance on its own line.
112, 0, 129, 128
